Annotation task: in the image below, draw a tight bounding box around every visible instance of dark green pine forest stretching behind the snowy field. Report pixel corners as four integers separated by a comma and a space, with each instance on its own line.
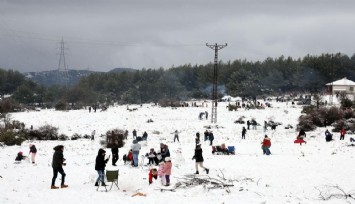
0, 53, 355, 107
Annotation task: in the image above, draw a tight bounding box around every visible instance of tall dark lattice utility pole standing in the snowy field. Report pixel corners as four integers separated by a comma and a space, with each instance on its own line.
206, 43, 227, 123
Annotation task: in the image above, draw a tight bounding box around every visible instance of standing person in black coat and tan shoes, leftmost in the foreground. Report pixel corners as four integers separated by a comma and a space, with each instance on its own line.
51, 145, 68, 189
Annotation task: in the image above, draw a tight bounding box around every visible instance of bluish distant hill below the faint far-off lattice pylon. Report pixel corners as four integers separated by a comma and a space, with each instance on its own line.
24, 70, 97, 86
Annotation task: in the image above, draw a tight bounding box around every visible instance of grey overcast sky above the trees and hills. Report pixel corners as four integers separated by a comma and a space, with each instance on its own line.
0, 0, 355, 72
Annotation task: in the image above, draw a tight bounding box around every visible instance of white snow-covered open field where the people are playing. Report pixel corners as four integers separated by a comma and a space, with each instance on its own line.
0, 102, 355, 204
